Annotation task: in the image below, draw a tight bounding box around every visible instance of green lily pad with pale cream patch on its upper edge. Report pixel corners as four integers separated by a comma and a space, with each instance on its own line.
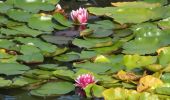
28, 14, 54, 32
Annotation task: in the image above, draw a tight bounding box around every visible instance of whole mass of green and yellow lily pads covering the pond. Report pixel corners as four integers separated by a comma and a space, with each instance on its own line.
0, 0, 170, 100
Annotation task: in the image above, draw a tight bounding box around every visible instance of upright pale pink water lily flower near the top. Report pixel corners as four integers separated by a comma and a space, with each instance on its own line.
71, 7, 88, 24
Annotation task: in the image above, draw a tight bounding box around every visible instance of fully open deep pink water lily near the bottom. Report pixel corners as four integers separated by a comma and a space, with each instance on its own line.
75, 74, 97, 89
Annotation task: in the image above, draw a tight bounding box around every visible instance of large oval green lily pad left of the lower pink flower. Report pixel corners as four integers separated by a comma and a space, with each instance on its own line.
30, 82, 75, 97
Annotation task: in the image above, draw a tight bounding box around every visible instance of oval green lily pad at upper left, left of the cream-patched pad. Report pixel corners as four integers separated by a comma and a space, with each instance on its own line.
7, 9, 32, 22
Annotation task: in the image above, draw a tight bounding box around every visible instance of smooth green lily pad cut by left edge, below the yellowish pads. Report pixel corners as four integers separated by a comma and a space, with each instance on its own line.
0, 63, 30, 75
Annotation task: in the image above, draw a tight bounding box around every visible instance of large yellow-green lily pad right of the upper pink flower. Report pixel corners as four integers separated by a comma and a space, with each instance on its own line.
88, 2, 160, 24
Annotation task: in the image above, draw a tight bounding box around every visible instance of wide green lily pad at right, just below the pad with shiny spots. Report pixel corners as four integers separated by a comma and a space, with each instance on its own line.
123, 37, 160, 55
